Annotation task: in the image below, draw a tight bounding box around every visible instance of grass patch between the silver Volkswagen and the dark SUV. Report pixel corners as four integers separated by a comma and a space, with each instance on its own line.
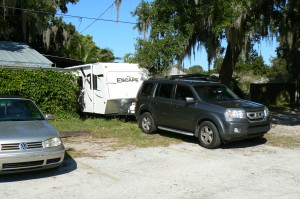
51, 118, 181, 147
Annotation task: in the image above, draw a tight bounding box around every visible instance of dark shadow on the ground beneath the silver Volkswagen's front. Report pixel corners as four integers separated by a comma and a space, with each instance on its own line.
0, 153, 77, 183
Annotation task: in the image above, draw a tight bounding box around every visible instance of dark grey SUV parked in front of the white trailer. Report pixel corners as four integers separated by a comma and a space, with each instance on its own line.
135, 79, 271, 149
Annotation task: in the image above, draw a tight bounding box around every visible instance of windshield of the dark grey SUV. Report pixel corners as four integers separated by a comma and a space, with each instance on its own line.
194, 85, 239, 102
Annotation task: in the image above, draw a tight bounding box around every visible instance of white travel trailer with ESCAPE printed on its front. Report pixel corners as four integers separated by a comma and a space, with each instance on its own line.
66, 63, 148, 115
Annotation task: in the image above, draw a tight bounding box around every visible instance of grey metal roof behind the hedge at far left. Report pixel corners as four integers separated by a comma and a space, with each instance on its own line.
0, 41, 52, 68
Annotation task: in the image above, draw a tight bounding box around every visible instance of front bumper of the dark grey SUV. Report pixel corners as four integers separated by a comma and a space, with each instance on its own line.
220, 120, 271, 142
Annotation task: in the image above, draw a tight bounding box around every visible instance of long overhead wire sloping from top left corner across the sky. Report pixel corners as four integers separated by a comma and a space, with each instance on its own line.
0, 5, 137, 25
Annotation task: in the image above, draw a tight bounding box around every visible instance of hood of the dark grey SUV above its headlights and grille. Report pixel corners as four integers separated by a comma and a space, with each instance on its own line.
211, 100, 264, 111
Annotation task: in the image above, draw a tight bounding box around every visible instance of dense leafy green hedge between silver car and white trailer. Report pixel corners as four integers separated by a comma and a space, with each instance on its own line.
0, 68, 78, 114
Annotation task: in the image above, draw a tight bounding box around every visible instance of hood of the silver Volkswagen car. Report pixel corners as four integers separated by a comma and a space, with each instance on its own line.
0, 120, 59, 143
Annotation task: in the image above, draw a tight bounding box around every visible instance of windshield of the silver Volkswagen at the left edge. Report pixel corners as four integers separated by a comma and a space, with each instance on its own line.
0, 99, 44, 121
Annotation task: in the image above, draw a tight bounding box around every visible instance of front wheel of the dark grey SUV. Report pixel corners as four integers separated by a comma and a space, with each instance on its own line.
198, 121, 221, 149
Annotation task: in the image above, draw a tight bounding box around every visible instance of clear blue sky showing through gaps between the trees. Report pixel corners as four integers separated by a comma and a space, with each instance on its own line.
63, 0, 278, 71
